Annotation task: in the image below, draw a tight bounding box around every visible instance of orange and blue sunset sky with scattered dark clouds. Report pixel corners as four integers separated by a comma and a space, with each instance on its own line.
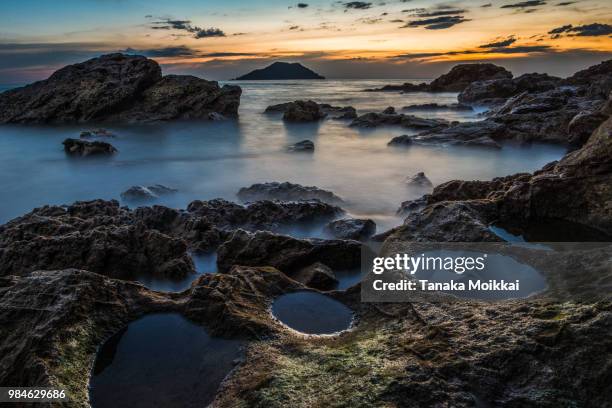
0, 0, 612, 84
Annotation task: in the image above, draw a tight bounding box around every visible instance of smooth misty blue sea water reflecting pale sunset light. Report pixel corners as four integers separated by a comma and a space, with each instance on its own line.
0, 80, 564, 231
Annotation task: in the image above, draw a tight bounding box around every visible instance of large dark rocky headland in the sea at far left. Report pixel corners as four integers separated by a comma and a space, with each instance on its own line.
0, 54, 242, 124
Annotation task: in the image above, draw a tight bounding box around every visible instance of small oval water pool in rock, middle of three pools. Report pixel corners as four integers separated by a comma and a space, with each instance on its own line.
272, 291, 353, 334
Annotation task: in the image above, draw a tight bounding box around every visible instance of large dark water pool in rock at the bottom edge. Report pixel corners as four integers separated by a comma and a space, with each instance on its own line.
90, 313, 243, 408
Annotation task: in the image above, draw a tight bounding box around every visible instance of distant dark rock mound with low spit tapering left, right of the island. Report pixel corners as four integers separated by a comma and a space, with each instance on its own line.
366, 64, 512, 92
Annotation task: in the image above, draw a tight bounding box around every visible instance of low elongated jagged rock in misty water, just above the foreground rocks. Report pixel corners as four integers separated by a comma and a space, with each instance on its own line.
237, 181, 343, 204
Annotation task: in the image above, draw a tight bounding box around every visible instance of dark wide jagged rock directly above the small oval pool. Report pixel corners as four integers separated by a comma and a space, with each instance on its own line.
217, 230, 361, 276
